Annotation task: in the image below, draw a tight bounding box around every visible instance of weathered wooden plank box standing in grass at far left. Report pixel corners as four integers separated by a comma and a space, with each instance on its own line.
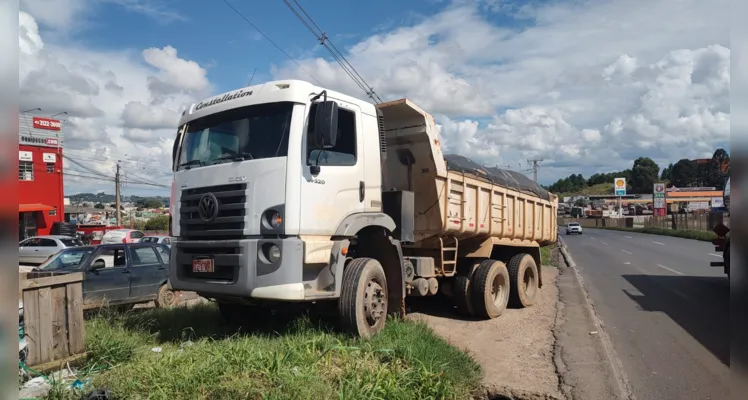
19, 272, 85, 370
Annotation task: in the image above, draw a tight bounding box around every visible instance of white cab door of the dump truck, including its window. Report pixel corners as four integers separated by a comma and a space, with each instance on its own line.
299, 102, 366, 235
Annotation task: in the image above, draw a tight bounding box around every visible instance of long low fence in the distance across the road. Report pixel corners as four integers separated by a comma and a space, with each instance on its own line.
558, 213, 730, 231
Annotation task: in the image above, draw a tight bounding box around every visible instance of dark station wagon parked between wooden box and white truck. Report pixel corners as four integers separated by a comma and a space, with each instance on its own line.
28, 243, 179, 307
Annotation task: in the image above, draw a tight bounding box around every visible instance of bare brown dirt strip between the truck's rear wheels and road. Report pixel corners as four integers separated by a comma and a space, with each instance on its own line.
409, 267, 563, 400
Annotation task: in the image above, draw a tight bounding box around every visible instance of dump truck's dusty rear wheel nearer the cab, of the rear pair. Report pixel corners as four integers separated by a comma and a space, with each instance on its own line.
470, 260, 510, 319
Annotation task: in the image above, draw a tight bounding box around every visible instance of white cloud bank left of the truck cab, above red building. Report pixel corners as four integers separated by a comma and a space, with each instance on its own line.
19, 11, 212, 193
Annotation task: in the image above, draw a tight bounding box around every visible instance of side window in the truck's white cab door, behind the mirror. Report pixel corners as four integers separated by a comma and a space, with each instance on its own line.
306, 104, 356, 166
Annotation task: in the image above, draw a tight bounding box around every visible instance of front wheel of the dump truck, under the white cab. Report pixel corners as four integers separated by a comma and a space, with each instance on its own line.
338, 257, 388, 339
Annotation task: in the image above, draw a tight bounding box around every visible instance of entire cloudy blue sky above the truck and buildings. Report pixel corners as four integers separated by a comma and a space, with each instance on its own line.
20, 0, 730, 192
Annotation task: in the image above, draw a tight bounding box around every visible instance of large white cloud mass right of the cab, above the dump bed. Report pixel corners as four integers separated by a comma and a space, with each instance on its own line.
275, 0, 730, 181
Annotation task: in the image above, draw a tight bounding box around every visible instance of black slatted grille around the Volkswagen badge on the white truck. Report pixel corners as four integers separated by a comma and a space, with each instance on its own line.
179, 183, 247, 240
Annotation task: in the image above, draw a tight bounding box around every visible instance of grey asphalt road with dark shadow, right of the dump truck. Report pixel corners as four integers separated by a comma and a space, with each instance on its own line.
559, 228, 730, 400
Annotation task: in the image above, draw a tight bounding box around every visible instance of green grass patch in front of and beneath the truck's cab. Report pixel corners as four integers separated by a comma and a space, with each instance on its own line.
49, 304, 482, 400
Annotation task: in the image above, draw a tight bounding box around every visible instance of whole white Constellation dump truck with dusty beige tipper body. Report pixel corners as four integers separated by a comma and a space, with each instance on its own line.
170, 80, 558, 337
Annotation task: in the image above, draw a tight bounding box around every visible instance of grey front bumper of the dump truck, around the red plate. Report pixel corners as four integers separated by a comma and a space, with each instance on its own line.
169, 238, 305, 301
